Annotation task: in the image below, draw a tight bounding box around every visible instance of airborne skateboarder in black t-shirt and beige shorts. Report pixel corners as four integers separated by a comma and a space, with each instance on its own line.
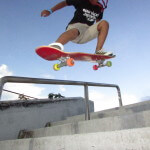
41, 0, 113, 55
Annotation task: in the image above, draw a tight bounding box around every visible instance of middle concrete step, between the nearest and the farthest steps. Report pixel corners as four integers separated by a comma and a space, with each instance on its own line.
21, 110, 150, 138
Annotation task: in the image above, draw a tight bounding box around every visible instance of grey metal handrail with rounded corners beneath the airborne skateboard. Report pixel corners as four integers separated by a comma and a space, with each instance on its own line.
0, 76, 122, 120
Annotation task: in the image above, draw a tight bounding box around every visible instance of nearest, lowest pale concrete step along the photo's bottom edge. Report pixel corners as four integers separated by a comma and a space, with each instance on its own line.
0, 128, 150, 150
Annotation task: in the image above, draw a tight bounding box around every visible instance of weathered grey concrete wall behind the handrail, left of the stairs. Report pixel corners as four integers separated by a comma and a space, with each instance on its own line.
0, 97, 94, 140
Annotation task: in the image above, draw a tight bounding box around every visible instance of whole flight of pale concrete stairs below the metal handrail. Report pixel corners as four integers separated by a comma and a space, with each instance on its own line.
0, 101, 150, 150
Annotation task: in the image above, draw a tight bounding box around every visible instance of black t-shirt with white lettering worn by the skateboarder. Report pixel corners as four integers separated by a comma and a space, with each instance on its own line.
66, 0, 103, 26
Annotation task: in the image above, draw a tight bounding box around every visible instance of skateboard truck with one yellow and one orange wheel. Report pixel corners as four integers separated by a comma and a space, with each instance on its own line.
53, 57, 74, 71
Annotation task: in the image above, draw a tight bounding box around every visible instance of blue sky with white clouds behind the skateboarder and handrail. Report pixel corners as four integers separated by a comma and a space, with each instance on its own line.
0, 0, 150, 109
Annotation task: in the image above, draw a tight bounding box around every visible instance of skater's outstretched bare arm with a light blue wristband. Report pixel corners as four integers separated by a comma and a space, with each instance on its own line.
41, 1, 67, 17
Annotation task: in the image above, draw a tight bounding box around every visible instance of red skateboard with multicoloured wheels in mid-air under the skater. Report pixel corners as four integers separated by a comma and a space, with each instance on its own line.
35, 46, 115, 71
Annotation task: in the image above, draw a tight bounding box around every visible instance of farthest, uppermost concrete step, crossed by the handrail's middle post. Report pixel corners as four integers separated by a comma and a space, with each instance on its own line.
47, 101, 150, 126
